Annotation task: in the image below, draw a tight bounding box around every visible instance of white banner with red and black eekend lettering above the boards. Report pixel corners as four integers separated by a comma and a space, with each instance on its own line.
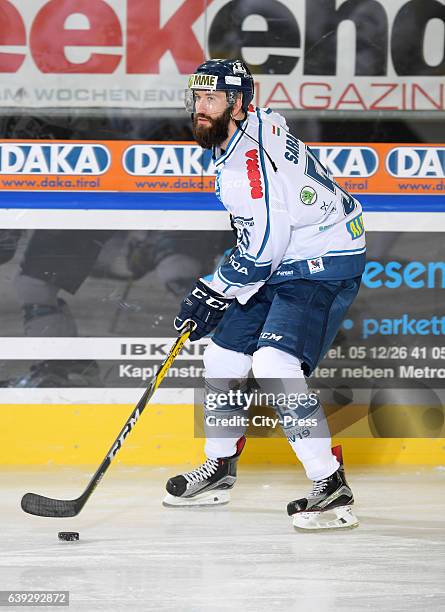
0, 0, 445, 113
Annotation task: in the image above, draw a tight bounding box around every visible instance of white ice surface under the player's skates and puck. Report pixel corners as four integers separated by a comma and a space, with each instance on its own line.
0, 465, 445, 612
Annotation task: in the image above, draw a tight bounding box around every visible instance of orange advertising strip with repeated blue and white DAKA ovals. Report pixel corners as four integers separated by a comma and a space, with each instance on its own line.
0, 140, 445, 197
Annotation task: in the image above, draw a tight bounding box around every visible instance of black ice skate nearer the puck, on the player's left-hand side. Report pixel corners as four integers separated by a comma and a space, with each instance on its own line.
162, 436, 246, 506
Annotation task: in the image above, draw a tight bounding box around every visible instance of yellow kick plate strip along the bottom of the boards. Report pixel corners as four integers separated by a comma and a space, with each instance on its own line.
0, 404, 445, 467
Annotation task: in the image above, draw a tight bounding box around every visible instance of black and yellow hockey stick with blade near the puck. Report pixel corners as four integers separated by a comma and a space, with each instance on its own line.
22, 326, 192, 518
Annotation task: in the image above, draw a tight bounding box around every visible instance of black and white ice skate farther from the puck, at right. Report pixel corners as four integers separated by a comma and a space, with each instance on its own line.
287, 446, 358, 531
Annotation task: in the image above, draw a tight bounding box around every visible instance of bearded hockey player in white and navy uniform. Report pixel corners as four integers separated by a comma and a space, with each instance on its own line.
164, 60, 365, 529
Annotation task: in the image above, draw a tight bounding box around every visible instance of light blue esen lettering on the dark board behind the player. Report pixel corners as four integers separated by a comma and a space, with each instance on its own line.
362, 261, 445, 289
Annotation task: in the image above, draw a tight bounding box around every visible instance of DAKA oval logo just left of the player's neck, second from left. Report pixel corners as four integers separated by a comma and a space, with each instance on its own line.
123, 144, 215, 176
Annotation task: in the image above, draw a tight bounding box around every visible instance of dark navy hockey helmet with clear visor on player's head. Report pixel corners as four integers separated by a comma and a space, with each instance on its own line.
185, 59, 255, 113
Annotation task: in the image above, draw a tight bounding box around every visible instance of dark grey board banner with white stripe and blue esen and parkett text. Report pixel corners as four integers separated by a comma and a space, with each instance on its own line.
0, 229, 445, 433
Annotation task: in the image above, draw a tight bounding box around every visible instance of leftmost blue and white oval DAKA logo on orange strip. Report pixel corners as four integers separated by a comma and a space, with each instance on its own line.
0, 142, 111, 176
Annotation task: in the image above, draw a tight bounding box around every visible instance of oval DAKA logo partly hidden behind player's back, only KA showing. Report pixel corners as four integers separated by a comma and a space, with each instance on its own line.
311, 146, 379, 178
